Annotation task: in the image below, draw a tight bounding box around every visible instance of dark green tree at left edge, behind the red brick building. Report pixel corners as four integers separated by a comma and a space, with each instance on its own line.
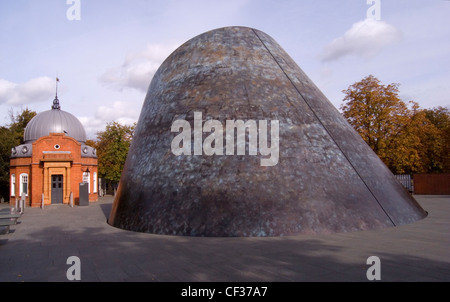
0, 108, 36, 200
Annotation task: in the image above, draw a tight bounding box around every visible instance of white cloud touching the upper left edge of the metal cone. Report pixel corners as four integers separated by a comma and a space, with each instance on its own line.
99, 43, 178, 93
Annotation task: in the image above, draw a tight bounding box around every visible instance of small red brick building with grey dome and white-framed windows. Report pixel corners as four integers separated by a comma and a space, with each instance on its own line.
10, 97, 98, 207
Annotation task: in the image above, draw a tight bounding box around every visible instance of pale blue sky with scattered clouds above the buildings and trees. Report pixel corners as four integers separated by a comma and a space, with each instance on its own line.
0, 0, 450, 139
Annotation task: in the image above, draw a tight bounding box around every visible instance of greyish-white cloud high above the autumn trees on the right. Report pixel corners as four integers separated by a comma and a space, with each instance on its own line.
321, 18, 401, 62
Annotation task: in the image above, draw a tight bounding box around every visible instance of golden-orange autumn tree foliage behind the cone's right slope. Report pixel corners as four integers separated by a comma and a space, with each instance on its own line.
341, 75, 443, 174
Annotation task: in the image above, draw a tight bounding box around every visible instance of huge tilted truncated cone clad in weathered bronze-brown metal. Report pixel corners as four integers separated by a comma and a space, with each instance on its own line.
108, 27, 426, 236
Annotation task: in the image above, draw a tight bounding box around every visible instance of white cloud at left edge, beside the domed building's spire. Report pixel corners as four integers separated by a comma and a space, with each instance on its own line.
0, 77, 55, 105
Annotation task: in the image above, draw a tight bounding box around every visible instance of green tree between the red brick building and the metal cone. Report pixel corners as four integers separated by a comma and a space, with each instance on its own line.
95, 122, 136, 193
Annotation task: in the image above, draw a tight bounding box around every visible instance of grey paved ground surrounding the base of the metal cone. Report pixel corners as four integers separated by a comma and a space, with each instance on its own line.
0, 196, 450, 282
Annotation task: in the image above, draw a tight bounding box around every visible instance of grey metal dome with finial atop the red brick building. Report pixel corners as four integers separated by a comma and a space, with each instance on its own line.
24, 97, 86, 143
